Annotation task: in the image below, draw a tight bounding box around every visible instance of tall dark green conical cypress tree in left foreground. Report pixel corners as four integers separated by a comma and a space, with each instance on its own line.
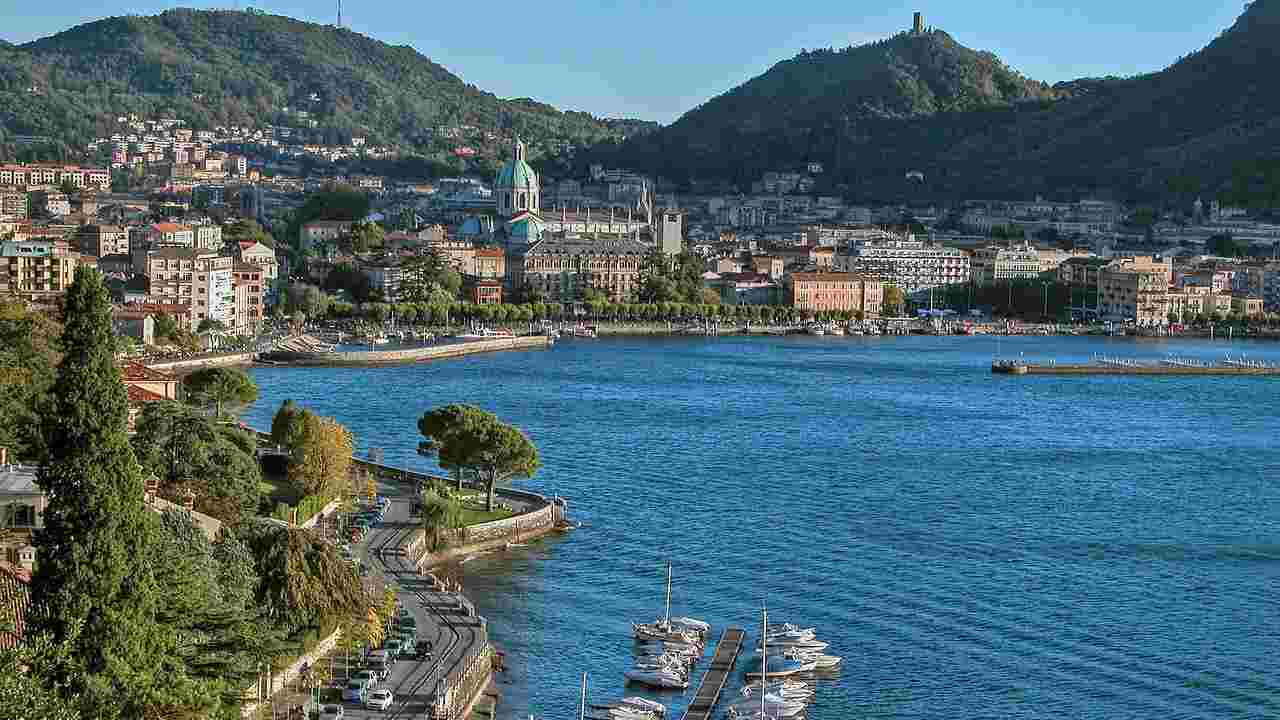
32, 268, 170, 717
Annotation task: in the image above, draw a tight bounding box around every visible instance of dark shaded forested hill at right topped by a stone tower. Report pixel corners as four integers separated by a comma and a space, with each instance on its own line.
598, 0, 1280, 200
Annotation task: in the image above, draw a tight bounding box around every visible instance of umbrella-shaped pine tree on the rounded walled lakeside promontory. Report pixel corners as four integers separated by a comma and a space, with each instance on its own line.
417, 405, 541, 511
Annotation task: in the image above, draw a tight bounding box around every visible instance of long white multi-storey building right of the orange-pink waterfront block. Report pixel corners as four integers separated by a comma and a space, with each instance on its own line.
836, 240, 970, 295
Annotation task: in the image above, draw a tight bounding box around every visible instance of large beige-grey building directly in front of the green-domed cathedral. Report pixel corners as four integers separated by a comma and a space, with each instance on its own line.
516, 236, 653, 302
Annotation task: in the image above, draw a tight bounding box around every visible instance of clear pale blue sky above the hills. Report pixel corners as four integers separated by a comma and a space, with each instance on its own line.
0, 0, 1244, 123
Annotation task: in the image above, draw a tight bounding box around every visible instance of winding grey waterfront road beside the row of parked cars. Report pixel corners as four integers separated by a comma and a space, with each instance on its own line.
335, 480, 484, 720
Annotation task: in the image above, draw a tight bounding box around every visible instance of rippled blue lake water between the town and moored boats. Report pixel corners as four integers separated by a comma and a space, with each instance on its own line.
248, 337, 1280, 720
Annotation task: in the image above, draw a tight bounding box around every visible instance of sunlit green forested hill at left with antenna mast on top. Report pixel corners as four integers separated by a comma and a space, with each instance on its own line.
0, 9, 654, 156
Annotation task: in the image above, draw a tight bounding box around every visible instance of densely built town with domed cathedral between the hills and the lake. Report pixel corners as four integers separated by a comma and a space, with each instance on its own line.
0, 112, 1280, 348
